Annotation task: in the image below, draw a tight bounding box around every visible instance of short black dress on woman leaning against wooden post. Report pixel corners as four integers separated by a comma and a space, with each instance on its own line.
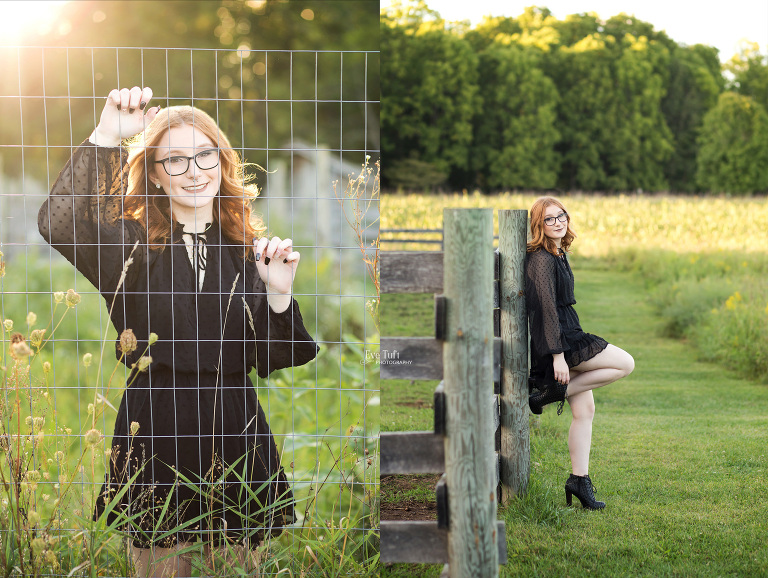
525, 249, 608, 380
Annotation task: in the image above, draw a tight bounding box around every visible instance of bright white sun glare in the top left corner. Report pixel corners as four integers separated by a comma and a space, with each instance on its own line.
0, 0, 72, 46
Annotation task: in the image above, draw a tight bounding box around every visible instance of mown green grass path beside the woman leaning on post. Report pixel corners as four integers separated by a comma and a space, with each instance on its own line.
382, 261, 768, 577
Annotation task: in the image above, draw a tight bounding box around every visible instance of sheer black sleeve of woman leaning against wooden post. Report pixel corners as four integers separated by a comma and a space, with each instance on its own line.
525, 249, 564, 356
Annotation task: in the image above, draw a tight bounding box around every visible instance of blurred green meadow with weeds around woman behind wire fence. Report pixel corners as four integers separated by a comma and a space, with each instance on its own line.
0, 250, 379, 576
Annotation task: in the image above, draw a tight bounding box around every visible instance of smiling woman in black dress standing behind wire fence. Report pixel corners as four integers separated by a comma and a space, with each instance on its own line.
38, 87, 317, 576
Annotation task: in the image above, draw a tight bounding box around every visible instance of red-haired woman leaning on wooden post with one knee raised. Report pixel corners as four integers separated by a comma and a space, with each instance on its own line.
525, 197, 635, 509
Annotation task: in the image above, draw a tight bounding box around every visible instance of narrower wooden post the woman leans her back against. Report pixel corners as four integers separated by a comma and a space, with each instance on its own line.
499, 210, 531, 503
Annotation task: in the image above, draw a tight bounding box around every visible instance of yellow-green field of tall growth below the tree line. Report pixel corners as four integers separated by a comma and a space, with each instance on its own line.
381, 193, 768, 382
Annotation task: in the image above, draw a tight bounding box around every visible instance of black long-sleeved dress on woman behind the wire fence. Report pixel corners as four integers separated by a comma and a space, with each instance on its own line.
38, 141, 317, 547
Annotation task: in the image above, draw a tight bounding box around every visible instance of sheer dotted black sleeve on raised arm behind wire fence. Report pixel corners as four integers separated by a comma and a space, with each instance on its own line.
37, 140, 146, 293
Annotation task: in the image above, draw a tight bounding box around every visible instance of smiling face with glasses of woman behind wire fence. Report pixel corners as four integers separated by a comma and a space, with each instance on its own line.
149, 124, 221, 214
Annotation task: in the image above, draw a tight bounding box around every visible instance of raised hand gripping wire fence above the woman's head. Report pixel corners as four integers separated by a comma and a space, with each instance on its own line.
89, 86, 160, 147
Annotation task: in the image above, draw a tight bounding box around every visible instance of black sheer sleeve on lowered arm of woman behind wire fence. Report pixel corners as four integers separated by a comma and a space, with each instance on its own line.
253, 267, 319, 377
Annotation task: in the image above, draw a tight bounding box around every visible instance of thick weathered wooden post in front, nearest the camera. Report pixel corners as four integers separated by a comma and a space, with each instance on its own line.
443, 209, 499, 578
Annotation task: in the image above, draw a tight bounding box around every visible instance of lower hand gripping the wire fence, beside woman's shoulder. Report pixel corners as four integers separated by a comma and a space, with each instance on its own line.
253, 237, 301, 313
